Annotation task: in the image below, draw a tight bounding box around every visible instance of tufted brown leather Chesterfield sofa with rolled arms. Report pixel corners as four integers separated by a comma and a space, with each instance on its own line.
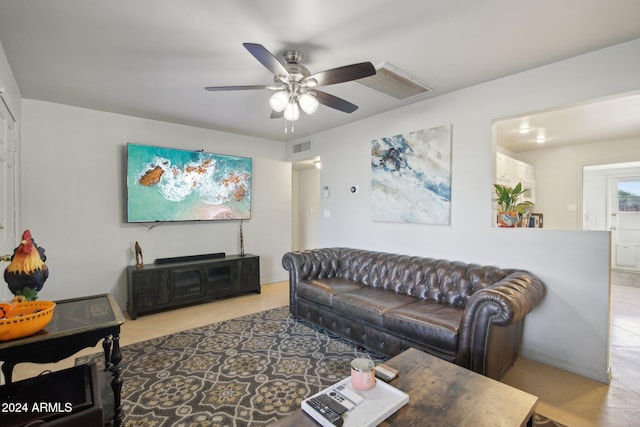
282, 248, 544, 379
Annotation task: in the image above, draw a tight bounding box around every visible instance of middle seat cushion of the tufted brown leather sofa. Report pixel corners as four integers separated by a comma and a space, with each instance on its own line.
333, 286, 417, 326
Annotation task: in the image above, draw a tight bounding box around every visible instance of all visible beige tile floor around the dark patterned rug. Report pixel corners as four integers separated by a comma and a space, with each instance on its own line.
6, 282, 640, 427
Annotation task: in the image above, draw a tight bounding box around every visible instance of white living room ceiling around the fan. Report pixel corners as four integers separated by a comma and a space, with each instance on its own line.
0, 0, 640, 141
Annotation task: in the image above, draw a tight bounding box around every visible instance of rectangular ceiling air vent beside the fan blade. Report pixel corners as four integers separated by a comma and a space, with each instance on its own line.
356, 62, 433, 99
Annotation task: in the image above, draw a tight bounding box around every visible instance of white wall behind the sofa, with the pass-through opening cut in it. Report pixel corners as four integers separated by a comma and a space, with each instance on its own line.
294, 40, 640, 382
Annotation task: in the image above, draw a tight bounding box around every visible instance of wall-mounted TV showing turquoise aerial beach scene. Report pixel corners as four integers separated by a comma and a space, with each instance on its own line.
127, 144, 252, 222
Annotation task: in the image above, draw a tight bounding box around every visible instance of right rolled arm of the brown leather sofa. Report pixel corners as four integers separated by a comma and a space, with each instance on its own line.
458, 270, 544, 373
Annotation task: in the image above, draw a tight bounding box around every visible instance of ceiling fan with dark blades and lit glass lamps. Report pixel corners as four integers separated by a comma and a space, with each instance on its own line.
205, 43, 376, 127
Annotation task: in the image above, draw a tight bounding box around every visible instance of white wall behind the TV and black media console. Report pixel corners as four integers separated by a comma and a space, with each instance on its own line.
21, 100, 291, 309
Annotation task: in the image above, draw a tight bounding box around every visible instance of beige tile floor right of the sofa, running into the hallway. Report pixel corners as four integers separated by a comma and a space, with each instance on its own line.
501, 285, 640, 427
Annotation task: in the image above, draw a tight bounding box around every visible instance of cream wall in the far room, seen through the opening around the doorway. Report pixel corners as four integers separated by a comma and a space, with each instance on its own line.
515, 137, 640, 230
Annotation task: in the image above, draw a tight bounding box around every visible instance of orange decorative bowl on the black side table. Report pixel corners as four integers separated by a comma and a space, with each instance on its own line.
0, 301, 56, 341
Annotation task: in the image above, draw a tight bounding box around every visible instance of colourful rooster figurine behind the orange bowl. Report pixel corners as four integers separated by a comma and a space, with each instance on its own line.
4, 230, 49, 300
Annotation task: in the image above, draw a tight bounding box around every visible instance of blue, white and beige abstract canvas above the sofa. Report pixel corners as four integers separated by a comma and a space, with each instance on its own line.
371, 125, 451, 225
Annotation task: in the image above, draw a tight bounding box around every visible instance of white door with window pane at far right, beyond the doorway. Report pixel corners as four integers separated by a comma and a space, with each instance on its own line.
609, 176, 640, 271
